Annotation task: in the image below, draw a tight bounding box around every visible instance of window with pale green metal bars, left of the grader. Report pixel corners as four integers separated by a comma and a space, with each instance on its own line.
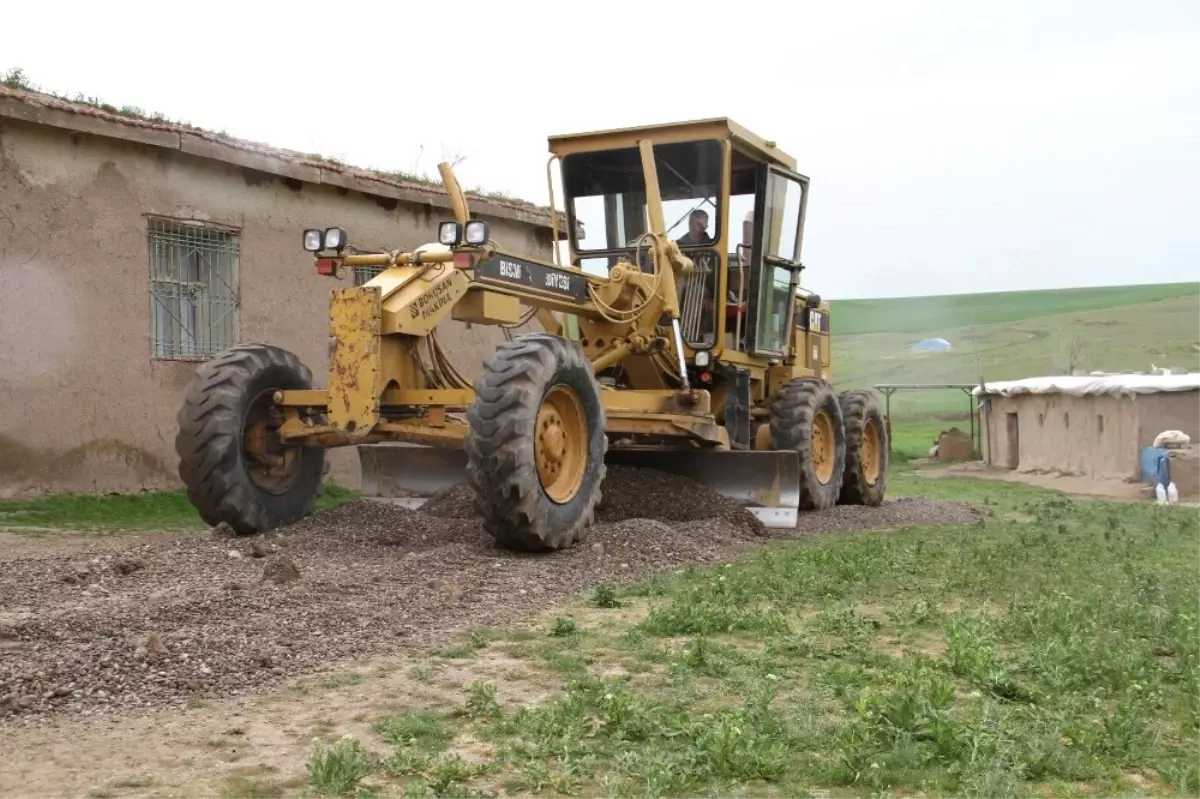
149, 218, 238, 360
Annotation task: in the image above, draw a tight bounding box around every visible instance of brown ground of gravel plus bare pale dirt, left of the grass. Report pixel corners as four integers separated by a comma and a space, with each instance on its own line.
0, 469, 977, 797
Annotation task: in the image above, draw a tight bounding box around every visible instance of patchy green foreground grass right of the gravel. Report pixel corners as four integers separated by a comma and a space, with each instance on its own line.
290, 473, 1200, 798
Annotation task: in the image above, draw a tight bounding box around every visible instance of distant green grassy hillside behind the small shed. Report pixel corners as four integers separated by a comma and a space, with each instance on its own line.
832, 283, 1200, 419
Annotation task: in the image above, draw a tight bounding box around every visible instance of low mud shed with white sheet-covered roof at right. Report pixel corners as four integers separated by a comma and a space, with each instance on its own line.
973, 374, 1200, 480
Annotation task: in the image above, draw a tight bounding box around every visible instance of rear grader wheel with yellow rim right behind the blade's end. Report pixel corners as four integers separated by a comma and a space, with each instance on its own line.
770, 378, 846, 510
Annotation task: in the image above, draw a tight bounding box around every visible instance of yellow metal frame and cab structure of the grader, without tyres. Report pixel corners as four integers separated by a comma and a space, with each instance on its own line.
274, 119, 829, 447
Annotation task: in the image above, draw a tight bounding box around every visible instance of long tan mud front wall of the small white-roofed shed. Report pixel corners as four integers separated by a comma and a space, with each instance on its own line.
984, 394, 1140, 480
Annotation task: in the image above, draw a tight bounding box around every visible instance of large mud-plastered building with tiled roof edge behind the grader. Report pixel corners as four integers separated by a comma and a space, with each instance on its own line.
0, 86, 553, 498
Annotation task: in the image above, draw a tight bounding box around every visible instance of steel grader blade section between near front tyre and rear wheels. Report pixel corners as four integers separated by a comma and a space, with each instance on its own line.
605, 449, 800, 529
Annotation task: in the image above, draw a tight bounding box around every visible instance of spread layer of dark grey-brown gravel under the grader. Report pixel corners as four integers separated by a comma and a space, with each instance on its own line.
0, 469, 977, 723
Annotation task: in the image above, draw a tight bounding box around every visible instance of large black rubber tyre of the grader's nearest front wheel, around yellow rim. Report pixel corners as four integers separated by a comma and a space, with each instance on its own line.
466, 334, 608, 551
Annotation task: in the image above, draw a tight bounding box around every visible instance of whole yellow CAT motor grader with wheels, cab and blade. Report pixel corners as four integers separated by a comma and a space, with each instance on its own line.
176, 119, 889, 549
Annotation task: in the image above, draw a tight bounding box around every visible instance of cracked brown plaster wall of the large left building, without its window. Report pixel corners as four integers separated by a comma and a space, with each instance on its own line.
0, 119, 551, 497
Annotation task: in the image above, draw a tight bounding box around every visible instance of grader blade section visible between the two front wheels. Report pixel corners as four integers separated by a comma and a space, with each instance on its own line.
359, 444, 467, 507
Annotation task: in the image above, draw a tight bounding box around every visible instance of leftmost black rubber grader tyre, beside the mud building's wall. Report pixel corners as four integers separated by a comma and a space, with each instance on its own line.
175, 344, 325, 535
